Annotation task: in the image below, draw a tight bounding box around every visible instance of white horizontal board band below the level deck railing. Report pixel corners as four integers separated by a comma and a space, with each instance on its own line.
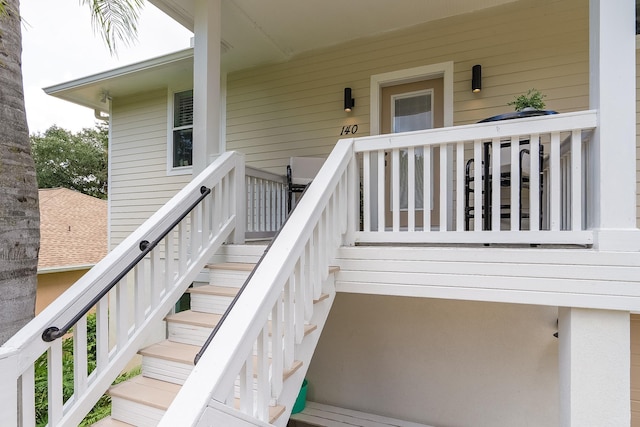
336, 247, 640, 311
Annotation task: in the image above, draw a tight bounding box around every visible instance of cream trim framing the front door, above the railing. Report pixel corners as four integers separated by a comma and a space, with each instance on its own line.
369, 61, 453, 135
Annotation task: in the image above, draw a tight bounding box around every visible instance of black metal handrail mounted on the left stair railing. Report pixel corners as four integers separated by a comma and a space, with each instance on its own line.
42, 186, 211, 342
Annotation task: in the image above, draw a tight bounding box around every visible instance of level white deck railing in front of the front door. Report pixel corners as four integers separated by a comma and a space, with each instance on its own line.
354, 111, 597, 245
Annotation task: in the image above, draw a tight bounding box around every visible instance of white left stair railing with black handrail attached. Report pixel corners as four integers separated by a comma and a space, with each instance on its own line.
0, 152, 245, 426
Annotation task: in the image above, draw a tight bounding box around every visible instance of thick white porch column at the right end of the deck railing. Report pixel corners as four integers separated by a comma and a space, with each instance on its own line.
589, 0, 640, 250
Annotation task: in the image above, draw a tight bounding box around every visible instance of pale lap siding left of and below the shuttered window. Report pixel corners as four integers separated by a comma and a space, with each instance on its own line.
109, 90, 191, 248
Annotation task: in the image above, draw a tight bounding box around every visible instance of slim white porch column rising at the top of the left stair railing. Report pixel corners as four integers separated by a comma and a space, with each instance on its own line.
193, 0, 224, 176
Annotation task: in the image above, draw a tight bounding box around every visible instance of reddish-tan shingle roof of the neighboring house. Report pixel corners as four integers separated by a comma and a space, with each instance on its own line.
38, 188, 107, 271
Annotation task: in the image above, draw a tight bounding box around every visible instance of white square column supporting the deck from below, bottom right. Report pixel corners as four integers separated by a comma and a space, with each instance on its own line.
558, 308, 631, 427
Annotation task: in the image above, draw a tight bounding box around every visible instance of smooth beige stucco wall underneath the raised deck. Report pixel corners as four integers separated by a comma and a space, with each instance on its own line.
307, 293, 560, 427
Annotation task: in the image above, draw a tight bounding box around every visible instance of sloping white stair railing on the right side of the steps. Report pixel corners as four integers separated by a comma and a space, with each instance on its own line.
160, 139, 359, 426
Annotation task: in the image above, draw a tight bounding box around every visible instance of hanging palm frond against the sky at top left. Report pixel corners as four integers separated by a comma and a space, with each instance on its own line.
81, 0, 144, 55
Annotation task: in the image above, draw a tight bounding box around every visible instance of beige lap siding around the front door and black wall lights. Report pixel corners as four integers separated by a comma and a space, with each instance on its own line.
227, 0, 588, 176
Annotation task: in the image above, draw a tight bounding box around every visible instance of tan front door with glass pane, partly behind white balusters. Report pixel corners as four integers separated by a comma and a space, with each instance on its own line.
380, 78, 444, 228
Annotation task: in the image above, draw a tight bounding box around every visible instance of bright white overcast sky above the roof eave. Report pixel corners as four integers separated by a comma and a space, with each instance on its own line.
20, 0, 192, 134
